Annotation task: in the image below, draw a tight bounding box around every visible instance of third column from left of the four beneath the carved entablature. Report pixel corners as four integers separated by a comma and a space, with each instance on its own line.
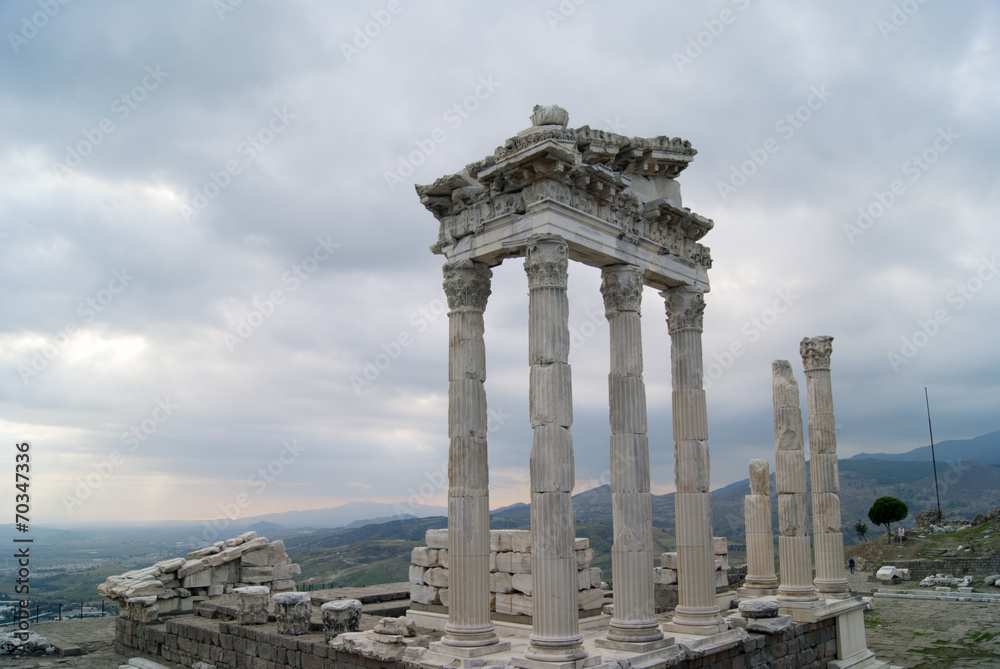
601, 265, 665, 647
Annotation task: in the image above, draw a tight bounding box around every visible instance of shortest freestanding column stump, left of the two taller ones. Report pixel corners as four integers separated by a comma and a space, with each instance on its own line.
739, 460, 778, 597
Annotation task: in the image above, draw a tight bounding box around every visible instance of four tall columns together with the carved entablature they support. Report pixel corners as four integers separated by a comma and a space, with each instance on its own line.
417, 107, 726, 665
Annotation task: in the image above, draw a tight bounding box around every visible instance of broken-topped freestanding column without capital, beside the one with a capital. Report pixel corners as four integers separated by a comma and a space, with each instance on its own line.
771, 360, 818, 613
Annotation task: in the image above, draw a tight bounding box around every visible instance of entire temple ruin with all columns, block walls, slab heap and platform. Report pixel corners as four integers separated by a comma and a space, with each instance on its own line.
105, 107, 900, 669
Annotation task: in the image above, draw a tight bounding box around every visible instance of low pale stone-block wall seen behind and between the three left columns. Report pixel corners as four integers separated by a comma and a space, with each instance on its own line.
410, 530, 604, 616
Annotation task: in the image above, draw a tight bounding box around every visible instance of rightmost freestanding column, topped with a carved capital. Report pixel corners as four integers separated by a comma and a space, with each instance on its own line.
799, 336, 851, 598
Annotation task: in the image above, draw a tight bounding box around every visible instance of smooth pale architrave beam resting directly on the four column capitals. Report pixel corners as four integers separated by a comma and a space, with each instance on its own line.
444, 200, 709, 292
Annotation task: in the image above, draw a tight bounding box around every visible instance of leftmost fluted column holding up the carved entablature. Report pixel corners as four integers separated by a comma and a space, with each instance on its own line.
441, 260, 497, 649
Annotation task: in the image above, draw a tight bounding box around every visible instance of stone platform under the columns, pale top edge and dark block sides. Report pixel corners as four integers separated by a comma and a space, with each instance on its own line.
115, 609, 852, 669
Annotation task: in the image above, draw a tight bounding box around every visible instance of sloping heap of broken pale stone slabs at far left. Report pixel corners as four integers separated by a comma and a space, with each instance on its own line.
97, 531, 301, 623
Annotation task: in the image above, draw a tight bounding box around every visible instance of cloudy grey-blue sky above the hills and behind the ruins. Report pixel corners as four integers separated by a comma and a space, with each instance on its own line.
0, 0, 1000, 527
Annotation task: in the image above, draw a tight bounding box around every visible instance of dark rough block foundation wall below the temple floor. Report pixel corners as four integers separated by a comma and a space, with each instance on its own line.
115, 616, 837, 669
